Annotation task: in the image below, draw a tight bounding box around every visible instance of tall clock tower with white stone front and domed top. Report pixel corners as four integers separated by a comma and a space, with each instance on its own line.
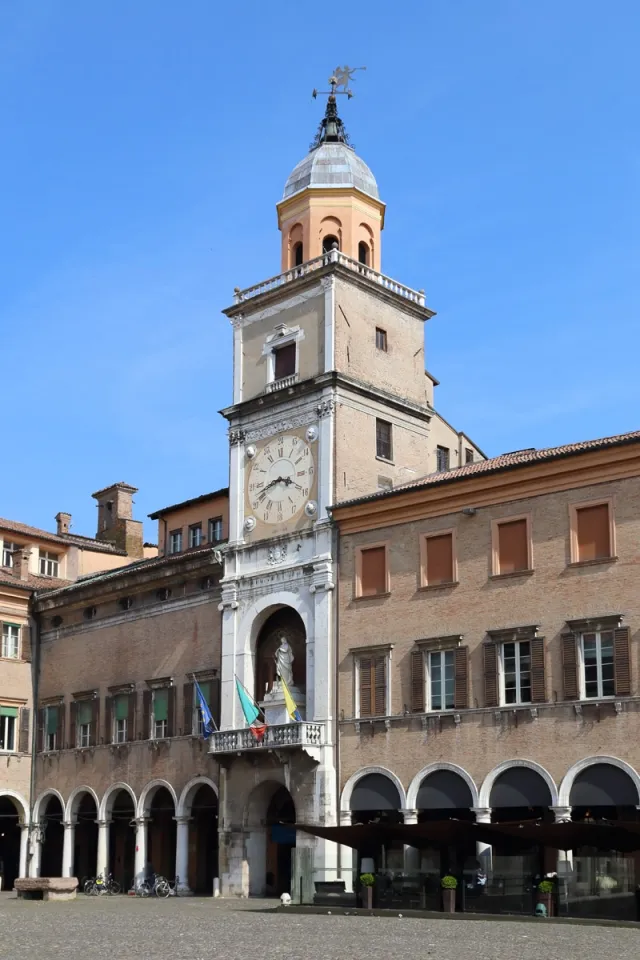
211, 85, 476, 895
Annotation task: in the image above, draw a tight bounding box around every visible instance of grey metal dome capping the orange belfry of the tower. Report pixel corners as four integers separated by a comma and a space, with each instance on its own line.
282, 141, 380, 200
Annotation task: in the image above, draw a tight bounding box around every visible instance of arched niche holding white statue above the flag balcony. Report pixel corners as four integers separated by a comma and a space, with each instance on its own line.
255, 607, 307, 702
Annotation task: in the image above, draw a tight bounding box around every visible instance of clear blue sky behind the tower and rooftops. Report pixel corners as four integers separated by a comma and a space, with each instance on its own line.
0, 0, 640, 539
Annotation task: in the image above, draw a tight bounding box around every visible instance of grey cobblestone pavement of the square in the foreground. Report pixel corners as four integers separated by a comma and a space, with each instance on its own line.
0, 896, 640, 960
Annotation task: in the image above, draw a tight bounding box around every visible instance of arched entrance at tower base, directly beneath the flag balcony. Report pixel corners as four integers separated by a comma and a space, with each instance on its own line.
246, 781, 296, 897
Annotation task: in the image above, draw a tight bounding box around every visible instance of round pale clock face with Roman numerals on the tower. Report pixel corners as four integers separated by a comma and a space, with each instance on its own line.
248, 434, 315, 523
